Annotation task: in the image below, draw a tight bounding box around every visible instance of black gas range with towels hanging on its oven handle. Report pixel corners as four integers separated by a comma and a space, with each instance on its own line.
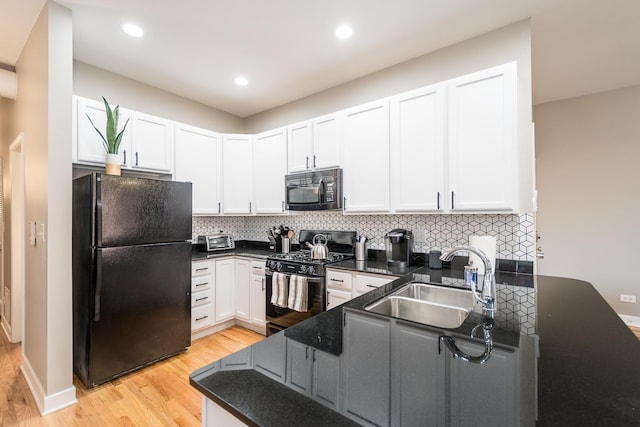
265, 230, 357, 336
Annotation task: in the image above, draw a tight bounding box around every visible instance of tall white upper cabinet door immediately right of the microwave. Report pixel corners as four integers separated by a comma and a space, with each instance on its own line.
343, 99, 389, 213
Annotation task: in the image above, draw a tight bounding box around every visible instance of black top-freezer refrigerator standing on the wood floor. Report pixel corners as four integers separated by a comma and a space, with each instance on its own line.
72, 173, 192, 387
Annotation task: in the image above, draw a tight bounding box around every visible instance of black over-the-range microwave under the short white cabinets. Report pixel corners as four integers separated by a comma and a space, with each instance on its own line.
284, 168, 342, 211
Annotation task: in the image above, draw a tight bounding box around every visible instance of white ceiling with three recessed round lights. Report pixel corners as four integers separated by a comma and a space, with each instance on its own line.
0, 0, 640, 117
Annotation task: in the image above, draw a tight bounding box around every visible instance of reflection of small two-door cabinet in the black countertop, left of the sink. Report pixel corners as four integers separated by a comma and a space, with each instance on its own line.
286, 339, 340, 411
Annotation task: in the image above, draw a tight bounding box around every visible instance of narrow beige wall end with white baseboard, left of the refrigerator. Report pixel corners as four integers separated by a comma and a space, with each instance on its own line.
9, 1, 75, 413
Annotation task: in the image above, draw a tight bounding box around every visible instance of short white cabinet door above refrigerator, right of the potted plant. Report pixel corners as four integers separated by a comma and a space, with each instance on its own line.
130, 113, 173, 173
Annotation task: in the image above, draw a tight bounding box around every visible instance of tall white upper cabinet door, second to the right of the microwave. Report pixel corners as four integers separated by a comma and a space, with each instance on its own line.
390, 85, 445, 212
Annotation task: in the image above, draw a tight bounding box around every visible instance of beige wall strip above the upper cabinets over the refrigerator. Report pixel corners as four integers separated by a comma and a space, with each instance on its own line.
73, 61, 244, 133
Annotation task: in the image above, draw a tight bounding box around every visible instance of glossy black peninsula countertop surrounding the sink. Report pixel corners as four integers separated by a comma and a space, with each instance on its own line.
190, 268, 640, 426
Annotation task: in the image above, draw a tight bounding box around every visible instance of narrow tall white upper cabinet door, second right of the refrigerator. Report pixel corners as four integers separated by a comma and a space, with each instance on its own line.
222, 134, 253, 215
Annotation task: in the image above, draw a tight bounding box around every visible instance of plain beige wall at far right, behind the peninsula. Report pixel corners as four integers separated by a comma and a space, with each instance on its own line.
534, 86, 640, 321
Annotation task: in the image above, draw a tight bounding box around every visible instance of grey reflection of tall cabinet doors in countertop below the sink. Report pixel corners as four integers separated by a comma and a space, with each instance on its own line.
343, 310, 533, 427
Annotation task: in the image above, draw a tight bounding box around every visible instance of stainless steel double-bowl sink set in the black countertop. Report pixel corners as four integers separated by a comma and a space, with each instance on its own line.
365, 282, 474, 328
